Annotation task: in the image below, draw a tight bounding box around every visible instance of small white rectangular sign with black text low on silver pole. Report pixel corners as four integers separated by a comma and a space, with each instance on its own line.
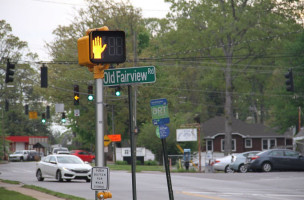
91, 167, 110, 190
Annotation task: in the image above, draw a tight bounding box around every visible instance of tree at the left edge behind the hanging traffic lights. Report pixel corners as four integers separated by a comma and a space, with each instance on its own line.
0, 20, 50, 158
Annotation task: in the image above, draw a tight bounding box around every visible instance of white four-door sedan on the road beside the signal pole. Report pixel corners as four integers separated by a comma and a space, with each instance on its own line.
36, 154, 92, 182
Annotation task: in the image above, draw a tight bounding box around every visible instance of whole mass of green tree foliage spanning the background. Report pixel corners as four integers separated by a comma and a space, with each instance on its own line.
0, 0, 304, 156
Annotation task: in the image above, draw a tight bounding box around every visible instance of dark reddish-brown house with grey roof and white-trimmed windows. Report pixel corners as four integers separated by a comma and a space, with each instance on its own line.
201, 116, 293, 153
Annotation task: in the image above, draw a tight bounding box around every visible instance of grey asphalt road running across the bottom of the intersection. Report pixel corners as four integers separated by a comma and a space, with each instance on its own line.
0, 162, 304, 200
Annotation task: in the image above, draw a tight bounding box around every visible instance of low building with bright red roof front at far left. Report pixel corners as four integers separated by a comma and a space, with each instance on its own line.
6, 136, 48, 154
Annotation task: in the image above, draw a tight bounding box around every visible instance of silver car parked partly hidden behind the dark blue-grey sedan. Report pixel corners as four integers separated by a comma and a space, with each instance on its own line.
229, 151, 261, 173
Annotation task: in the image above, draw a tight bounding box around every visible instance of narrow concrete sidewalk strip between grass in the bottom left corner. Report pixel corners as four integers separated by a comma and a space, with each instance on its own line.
0, 181, 63, 200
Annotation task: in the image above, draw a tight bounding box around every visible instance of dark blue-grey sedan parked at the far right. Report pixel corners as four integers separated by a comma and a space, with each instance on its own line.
248, 149, 304, 172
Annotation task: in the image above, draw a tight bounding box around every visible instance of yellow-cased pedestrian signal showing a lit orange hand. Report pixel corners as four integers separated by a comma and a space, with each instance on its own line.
77, 28, 126, 66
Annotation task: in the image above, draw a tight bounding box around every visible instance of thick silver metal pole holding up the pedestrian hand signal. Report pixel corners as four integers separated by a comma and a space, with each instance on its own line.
95, 78, 104, 199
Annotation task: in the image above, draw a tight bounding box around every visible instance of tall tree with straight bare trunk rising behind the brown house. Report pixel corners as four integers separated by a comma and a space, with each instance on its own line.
157, 0, 300, 155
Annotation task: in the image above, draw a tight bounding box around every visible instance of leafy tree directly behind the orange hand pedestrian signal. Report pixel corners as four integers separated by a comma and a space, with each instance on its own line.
46, 0, 149, 148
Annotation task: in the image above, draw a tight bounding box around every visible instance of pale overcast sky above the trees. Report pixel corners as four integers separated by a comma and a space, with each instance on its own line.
0, 0, 170, 61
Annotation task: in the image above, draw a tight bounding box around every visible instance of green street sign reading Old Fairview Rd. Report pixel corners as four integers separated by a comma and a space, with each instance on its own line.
103, 66, 156, 86
